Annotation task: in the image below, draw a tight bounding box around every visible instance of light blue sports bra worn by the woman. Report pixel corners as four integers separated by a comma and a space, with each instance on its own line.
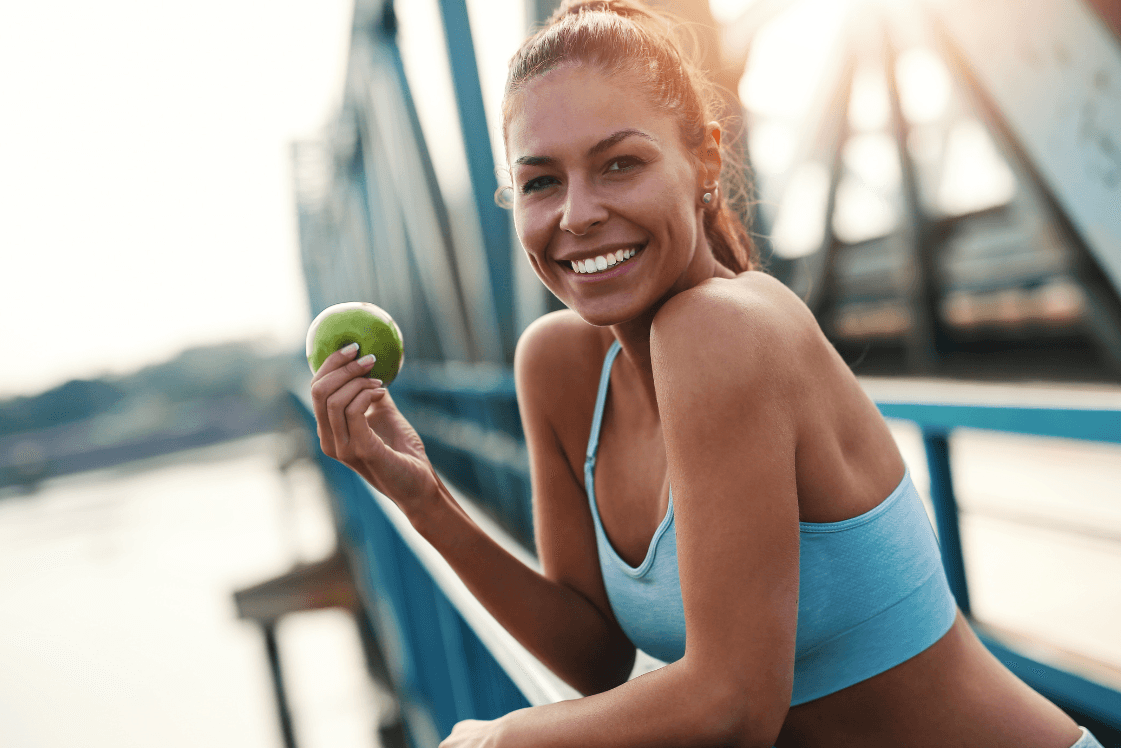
584, 341, 957, 707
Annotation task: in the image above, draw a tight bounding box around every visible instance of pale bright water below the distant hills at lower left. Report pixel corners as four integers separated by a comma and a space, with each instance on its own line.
0, 435, 382, 748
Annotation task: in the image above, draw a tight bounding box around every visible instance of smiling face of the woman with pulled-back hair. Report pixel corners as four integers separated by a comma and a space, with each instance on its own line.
507, 66, 719, 325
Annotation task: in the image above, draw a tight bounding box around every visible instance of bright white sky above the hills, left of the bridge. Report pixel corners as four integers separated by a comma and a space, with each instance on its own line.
0, 0, 352, 397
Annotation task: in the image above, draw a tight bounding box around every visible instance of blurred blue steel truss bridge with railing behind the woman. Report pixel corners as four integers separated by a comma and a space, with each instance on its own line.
252, 0, 1121, 746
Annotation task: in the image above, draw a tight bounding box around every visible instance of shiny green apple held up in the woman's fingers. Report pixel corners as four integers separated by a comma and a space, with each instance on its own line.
306, 302, 405, 386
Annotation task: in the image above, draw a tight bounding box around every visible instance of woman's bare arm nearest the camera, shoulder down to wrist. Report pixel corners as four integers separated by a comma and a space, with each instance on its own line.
455, 283, 798, 748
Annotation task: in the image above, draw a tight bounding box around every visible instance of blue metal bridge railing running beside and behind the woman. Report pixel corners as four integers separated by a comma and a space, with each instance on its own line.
297, 372, 1121, 745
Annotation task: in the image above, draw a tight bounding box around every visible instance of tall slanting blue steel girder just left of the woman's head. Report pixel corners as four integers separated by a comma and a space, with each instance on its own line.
439, 0, 517, 364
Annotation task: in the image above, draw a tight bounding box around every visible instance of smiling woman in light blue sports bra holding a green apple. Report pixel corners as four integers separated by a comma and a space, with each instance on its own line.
312, 0, 1099, 748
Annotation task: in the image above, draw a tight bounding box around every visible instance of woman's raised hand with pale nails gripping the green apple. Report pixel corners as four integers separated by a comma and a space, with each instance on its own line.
312, 343, 441, 515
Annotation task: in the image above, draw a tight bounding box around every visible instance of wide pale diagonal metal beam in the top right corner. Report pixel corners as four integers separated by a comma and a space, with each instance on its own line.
926, 0, 1121, 300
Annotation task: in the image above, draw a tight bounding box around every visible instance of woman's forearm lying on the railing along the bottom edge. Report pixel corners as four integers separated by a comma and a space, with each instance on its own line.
497, 661, 757, 748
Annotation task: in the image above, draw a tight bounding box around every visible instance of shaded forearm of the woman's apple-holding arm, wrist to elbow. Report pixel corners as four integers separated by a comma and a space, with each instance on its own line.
408, 486, 633, 694
